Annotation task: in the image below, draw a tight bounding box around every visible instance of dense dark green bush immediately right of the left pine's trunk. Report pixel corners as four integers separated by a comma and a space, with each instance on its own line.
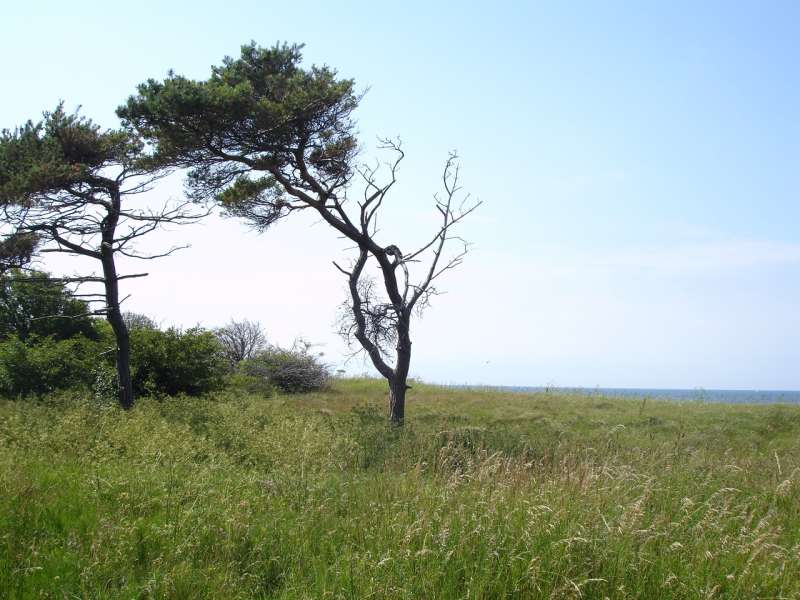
130, 327, 226, 396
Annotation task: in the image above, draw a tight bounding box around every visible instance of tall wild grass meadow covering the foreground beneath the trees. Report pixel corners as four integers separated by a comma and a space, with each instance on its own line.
0, 380, 800, 599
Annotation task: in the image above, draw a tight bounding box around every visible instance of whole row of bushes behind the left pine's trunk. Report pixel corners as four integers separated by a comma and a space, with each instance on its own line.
0, 271, 330, 398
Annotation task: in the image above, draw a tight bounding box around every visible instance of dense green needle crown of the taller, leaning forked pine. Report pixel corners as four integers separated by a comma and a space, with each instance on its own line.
117, 43, 359, 227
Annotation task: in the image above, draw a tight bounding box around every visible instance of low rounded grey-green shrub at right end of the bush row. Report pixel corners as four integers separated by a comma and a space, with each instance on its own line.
239, 346, 331, 394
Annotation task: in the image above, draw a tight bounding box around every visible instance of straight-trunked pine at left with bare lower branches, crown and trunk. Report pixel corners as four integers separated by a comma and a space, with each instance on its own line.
0, 105, 207, 409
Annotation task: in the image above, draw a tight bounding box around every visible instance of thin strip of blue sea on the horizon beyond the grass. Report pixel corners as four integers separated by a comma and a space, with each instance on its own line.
459, 386, 800, 404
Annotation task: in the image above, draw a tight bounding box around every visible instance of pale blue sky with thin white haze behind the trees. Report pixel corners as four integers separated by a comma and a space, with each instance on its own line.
0, 0, 800, 390
